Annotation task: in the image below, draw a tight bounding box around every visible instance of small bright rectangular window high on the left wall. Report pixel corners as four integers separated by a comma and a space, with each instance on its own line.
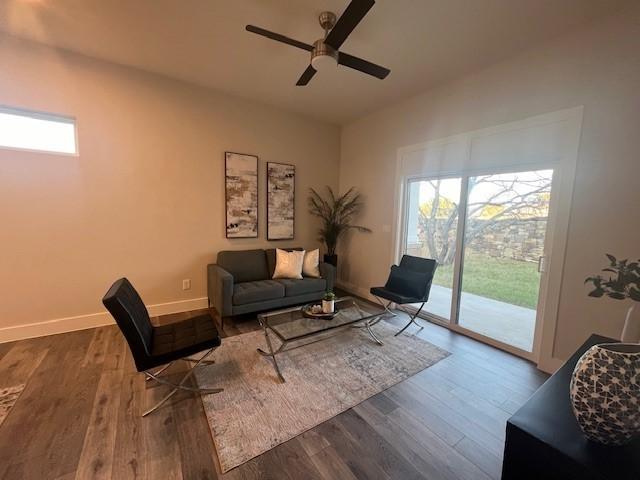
0, 106, 78, 155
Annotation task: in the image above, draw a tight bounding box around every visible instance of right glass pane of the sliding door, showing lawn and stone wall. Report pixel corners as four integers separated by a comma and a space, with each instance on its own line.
458, 170, 553, 352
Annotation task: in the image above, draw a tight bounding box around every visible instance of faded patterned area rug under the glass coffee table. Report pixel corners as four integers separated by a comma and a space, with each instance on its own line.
196, 322, 449, 473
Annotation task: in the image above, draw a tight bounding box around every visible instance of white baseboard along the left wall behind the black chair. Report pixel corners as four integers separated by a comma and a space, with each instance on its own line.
0, 297, 208, 343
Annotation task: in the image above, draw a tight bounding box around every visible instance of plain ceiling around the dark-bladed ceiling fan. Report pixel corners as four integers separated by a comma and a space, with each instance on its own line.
0, 0, 634, 123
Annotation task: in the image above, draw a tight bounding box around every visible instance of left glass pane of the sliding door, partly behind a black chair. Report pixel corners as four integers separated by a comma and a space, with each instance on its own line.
405, 178, 462, 320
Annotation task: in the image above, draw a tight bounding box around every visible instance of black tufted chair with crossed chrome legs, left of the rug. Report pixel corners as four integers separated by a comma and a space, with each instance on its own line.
102, 278, 222, 417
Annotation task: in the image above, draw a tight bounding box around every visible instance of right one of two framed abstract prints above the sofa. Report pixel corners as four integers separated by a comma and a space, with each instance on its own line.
267, 162, 296, 240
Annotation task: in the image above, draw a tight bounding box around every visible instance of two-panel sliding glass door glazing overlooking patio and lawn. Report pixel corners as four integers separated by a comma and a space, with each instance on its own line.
404, 170, 553, 352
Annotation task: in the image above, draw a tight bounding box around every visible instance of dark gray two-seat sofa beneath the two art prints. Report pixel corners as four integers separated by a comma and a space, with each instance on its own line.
207, 248, 336, 319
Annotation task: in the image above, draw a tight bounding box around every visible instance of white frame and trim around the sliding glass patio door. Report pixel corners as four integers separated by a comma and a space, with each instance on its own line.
390, 106, 584, 373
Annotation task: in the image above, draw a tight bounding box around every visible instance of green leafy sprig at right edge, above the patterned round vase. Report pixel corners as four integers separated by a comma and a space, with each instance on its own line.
584, 253, 640, 302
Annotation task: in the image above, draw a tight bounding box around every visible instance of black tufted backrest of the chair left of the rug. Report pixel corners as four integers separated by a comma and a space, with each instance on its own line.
102, 278, 153, 365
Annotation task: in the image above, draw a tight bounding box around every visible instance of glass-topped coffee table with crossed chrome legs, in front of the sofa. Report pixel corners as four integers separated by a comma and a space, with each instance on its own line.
258, 297, 387, 382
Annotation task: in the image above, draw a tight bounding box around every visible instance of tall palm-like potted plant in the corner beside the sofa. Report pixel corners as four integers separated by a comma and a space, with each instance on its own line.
309, 186, 371, 266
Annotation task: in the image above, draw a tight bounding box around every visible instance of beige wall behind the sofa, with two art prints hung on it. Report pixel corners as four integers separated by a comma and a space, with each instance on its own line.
0, 36, 340, 338
